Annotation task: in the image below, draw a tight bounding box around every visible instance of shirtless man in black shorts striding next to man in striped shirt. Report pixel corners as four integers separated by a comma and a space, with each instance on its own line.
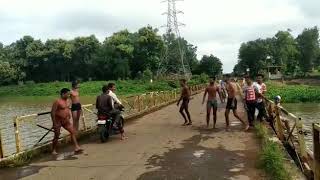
225, 76, 249, 131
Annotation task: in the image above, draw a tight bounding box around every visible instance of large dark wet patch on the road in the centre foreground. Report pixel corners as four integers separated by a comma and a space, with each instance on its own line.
137, 133, 256, 180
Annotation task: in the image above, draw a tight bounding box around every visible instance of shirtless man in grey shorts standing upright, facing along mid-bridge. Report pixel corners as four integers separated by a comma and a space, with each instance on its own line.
202, 79, 222, 129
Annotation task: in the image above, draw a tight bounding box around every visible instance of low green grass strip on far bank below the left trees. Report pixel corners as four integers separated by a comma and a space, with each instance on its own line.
0, 78, 204, 97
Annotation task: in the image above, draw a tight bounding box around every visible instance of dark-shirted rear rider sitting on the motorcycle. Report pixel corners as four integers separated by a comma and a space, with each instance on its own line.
96, 85, 125, 140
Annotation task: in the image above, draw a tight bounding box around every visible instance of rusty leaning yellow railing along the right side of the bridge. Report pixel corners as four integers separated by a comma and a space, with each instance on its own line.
238, 84, 320, 180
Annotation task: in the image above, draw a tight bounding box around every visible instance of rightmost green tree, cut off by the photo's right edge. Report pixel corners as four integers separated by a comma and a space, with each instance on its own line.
297, 27, 319, 75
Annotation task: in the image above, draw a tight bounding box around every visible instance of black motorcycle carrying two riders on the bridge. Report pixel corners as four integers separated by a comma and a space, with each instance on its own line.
97, 108, 124, 143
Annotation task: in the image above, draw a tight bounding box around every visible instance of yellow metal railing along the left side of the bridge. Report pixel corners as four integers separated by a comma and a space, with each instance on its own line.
0, 85, 205, 157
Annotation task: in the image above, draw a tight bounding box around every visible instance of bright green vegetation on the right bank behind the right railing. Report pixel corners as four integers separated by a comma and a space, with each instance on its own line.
266, 81, 320, 103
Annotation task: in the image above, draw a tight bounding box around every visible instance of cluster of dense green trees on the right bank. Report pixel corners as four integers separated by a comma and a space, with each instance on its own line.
234, 27, 320, 75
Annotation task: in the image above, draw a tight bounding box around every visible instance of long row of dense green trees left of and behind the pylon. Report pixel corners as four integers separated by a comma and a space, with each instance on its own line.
0, 26, 224, 85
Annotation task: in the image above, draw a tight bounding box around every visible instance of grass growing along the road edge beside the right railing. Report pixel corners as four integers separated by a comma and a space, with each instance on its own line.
255, 123, 292, 180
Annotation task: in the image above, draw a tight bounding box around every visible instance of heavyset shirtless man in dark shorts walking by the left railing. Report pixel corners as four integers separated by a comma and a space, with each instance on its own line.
51, 88, 83, 155
